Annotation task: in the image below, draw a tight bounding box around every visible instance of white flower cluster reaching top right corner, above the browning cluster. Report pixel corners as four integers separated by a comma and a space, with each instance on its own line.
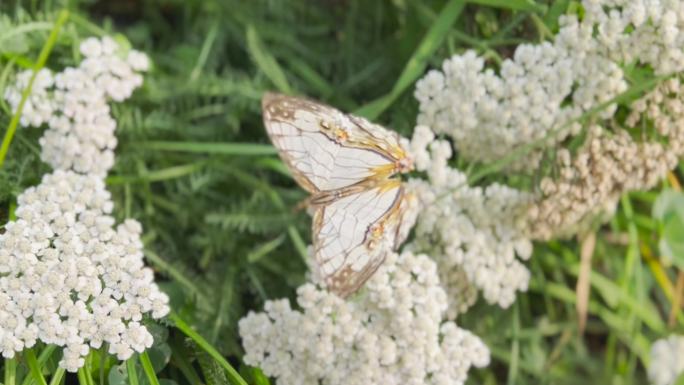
415, 0, 684, 169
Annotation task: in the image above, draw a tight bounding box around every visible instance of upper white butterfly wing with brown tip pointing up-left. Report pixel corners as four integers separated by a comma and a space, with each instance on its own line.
262, 93, 409, 194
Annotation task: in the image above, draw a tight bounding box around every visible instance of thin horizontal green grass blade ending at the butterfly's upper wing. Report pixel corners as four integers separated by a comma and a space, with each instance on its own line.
138, 141, 278, 156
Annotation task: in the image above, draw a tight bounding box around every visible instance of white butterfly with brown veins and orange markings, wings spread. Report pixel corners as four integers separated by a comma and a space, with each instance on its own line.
261, 93, 417, 298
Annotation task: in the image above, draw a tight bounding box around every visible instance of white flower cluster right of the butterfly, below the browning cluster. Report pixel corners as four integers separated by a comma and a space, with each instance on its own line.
407, 126, 532, 319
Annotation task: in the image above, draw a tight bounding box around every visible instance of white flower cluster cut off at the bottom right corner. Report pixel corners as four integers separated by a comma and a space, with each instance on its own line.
648, 335, 684, 385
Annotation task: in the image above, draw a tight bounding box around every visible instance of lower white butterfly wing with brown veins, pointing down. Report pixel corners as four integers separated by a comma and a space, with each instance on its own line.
313, 179, 415, 297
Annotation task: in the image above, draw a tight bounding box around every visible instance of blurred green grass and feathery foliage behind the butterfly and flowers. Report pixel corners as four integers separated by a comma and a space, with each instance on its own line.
0, 0, 684, 385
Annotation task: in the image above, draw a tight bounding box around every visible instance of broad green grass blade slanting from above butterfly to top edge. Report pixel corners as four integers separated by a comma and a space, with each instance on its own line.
354, 0, 465, 120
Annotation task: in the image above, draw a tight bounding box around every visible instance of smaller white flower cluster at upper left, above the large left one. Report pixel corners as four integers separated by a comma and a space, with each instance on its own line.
5, 37, 149, 176
